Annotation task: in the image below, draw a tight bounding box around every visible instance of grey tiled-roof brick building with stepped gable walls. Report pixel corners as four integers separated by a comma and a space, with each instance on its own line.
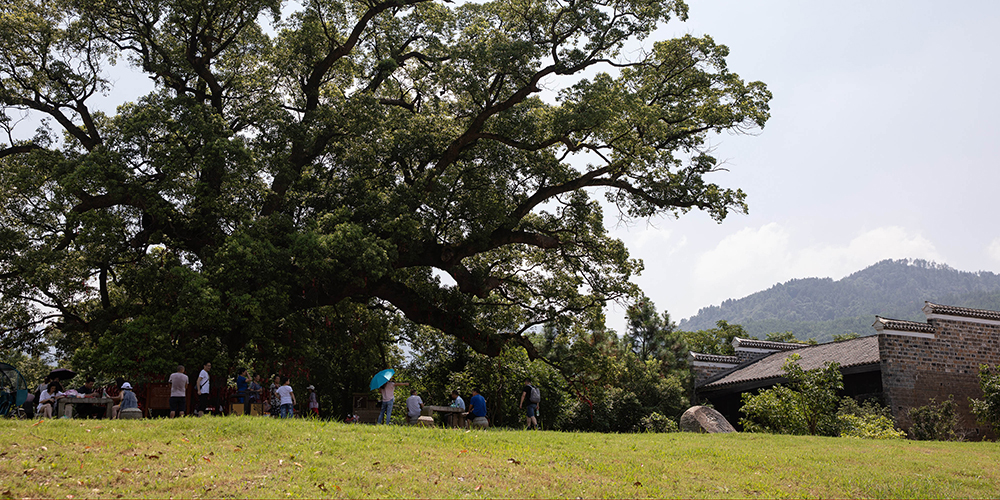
691, 302, 1000, 438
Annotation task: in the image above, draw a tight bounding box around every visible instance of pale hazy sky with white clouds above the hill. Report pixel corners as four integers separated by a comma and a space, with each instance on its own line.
606, 0, 1000, 332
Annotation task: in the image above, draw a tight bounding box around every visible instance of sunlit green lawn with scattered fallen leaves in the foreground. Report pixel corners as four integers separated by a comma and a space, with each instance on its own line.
0, 417, 1000, 499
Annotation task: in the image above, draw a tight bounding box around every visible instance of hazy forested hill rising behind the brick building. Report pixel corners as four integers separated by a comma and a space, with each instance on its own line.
678, 260, 1000, 342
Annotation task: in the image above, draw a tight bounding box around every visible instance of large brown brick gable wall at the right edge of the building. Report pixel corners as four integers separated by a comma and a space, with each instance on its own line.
879, 317, 1000, 439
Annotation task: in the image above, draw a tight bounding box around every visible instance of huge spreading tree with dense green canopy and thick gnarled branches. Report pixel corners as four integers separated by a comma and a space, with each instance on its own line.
0, 0, 770, 368
